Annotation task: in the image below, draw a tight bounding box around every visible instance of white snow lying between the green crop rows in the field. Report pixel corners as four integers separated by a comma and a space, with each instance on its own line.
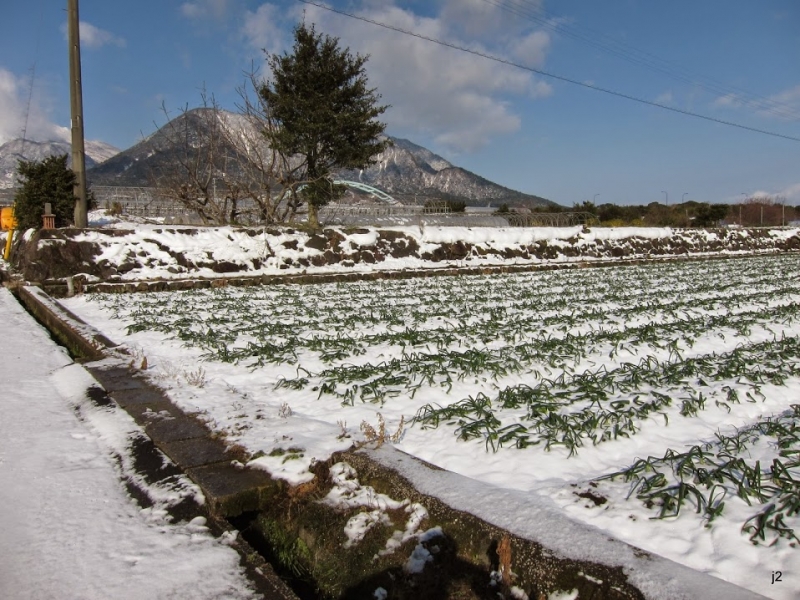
63, 250, 800, 600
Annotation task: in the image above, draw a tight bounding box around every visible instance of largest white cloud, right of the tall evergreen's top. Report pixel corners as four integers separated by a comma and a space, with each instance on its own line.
243, 0, 552, 152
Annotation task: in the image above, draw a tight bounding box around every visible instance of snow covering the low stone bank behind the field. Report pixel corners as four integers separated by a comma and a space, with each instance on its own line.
53, 211, 800, 281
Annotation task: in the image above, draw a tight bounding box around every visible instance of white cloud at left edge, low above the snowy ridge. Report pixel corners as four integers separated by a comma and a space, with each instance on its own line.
0, 68, 69, 144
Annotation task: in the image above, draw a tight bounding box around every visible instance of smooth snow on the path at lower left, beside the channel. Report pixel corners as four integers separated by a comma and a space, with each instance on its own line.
0, 288, 257, 600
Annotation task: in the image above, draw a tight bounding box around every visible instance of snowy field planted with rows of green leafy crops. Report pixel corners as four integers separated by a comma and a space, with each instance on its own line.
63, 255, 800, 598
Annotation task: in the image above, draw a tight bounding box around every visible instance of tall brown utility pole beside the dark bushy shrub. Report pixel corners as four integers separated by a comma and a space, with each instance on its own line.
67, 0, 89, 228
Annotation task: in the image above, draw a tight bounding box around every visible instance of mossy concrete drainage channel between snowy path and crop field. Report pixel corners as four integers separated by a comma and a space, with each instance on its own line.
9, 286, 760, 600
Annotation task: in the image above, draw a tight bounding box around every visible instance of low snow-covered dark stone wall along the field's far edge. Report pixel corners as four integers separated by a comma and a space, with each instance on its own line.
7, 227, 800, 289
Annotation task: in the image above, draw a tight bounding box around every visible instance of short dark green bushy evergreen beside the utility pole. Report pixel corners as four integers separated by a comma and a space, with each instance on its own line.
14, 154, 75, 231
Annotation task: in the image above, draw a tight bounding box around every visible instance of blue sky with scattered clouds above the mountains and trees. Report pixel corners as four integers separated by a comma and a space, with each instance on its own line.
0, 0, 800, 206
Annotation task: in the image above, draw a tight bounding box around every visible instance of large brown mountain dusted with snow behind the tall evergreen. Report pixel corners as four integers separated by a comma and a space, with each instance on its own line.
87, 108, 557, 207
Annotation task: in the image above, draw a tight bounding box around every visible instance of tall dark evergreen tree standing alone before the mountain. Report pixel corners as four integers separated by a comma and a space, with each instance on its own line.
259, 23, 388, 227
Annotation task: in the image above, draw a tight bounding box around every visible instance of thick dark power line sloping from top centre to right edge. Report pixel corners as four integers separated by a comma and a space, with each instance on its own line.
297, 0, 800, 142
